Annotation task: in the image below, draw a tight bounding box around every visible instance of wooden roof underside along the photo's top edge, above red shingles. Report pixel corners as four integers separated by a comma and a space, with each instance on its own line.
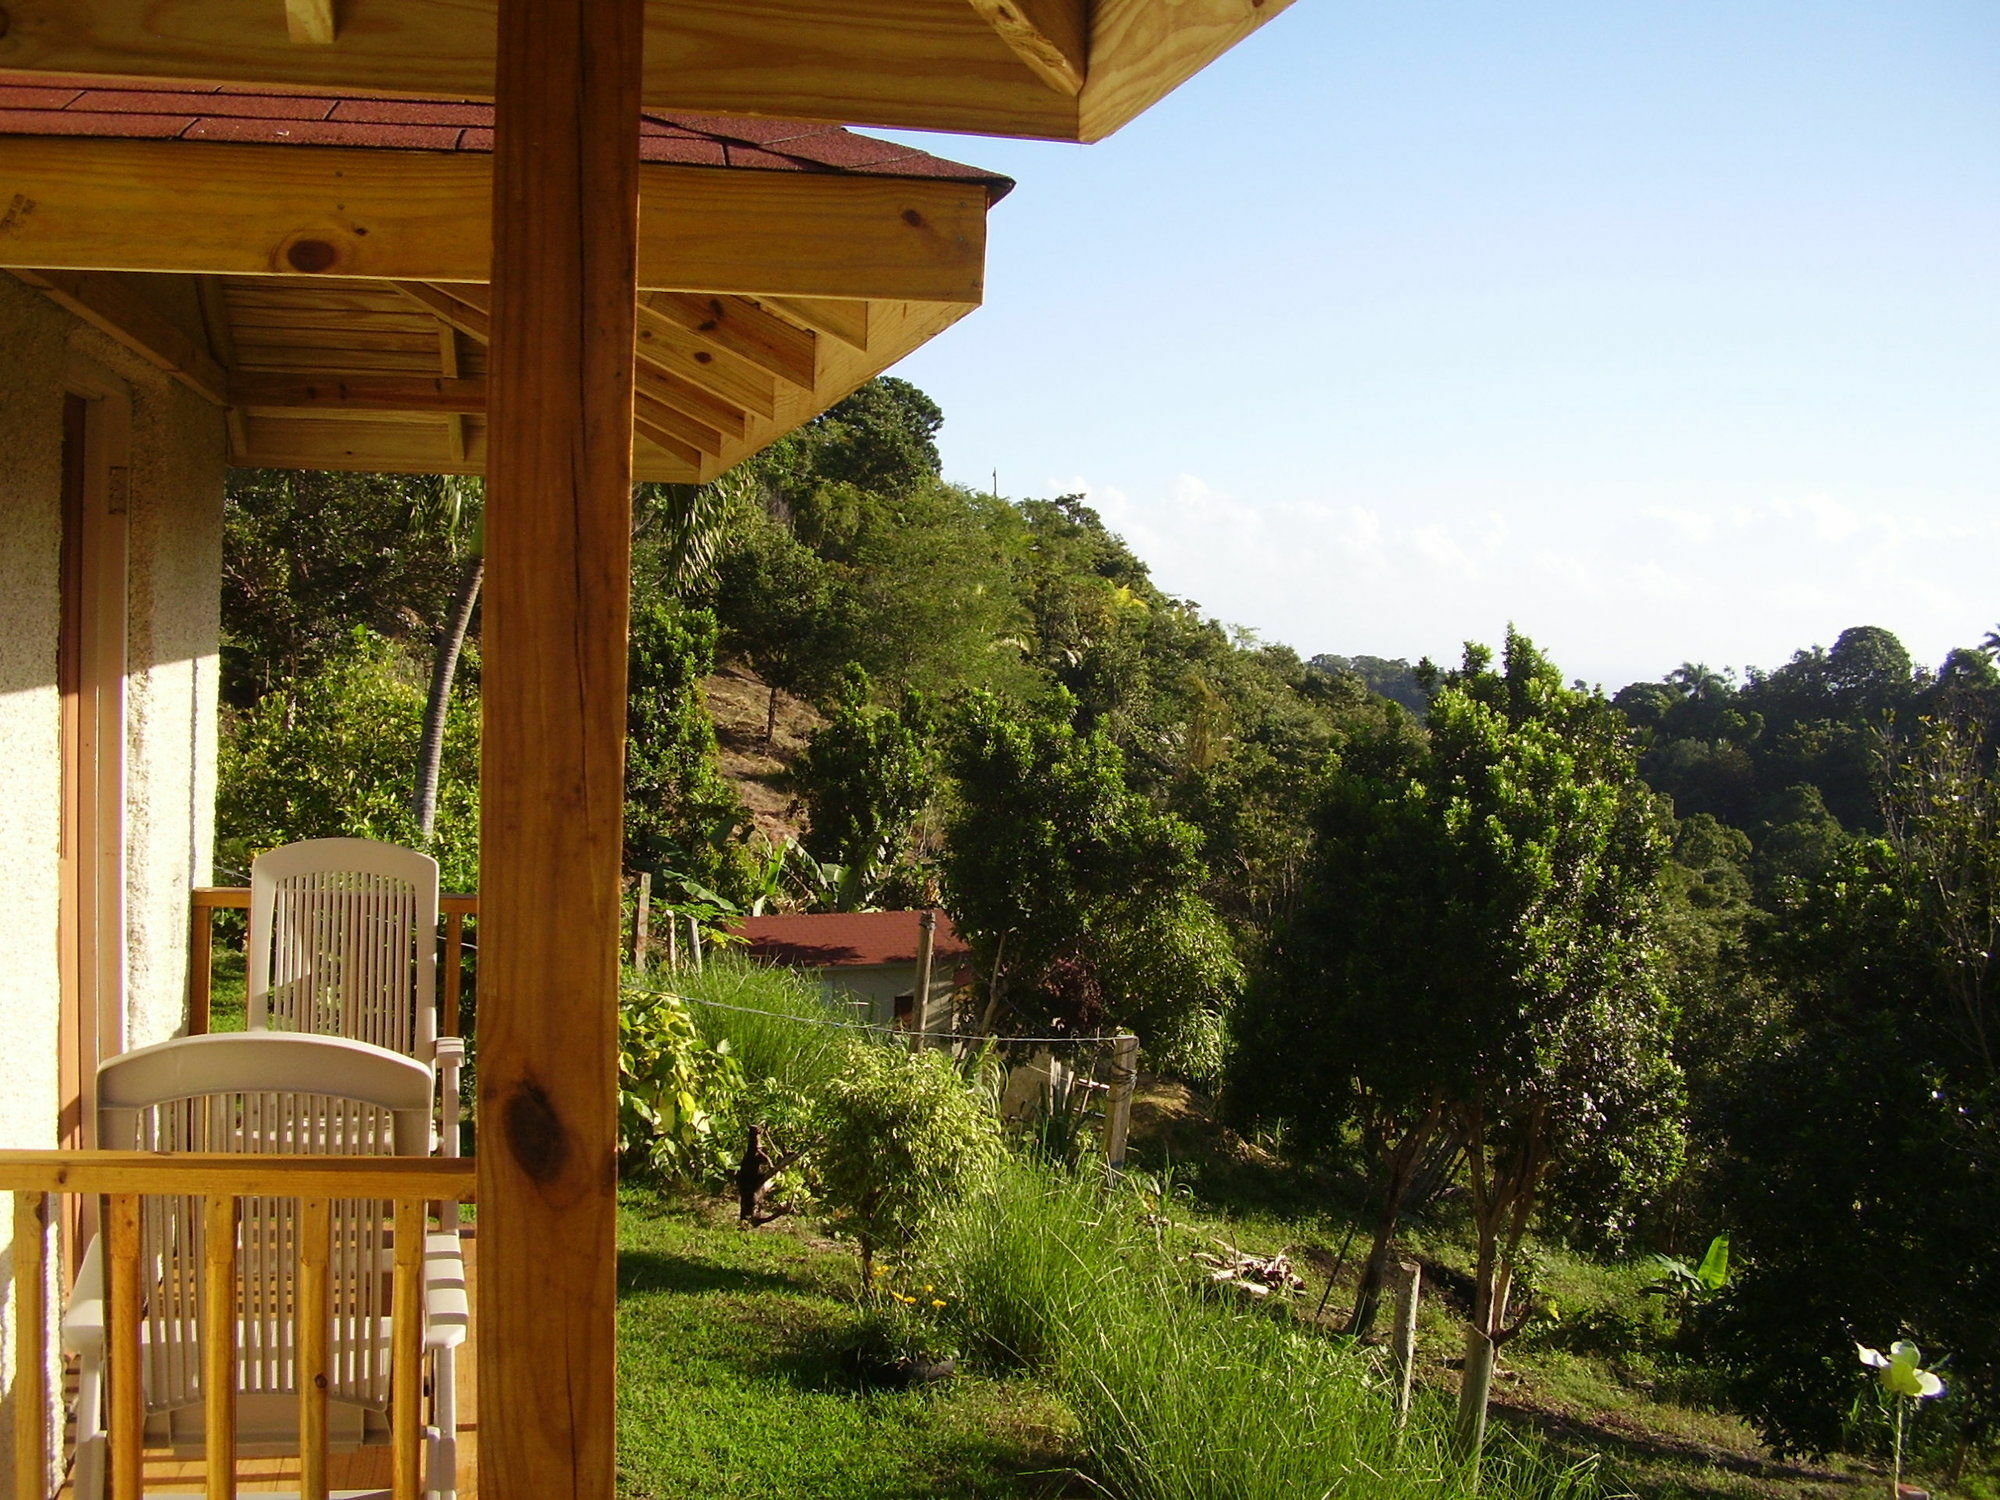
0, 0, 1288, 140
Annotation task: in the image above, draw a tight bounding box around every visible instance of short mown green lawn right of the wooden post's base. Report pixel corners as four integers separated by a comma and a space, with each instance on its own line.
618, 1188, 1096, 1500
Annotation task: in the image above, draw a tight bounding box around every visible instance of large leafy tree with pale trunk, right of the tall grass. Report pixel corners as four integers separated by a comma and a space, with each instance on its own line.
1238, 634, 1680, 1446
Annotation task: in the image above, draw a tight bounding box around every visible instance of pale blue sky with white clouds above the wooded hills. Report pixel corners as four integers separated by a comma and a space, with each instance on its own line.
876, 0, 2000, 688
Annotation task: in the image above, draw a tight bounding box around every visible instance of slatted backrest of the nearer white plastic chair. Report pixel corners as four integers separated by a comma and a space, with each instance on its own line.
98, 1032, 432, 1412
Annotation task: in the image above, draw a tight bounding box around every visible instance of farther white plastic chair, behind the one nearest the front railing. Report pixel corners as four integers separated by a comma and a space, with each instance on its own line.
248, 838, 466, 1156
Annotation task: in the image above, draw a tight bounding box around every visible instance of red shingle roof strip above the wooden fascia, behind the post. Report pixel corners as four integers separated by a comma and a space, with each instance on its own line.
0, 70, 1014, 202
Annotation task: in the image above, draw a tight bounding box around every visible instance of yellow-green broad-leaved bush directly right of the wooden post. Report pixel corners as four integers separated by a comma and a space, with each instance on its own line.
618, 990, 742, 1176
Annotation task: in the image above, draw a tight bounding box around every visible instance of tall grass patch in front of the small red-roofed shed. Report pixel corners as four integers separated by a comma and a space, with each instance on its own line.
640, 954, 856, 1094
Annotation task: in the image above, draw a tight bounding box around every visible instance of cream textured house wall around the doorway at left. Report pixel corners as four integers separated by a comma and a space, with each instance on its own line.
0, 272, 226, 1474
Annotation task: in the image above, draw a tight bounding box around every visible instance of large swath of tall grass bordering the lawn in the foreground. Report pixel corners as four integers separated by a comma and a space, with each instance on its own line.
926, 1160, 1590, 1500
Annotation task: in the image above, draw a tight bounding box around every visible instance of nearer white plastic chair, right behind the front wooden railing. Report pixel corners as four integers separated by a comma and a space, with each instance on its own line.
62, 1032, 470, 1500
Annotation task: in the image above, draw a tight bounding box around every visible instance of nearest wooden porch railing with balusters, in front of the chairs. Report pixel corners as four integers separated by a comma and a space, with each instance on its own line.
0, 1150, 474, 1500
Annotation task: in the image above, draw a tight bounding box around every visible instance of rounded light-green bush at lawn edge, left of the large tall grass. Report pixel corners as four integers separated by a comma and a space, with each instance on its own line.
814, 1042, 1000, 1280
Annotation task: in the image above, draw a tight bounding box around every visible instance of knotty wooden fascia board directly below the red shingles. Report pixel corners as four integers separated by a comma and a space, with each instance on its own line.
0, 136, 986, 306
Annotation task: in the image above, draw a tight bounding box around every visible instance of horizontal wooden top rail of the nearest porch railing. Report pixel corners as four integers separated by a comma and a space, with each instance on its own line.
0, 1150, 476, 1204
